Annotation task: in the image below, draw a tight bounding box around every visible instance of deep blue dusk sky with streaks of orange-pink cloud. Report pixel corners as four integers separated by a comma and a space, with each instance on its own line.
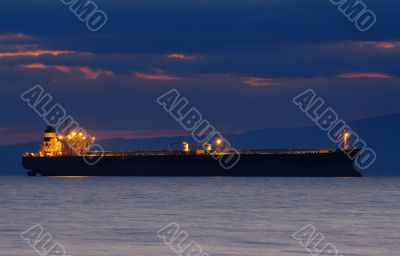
0, 0, 400, 145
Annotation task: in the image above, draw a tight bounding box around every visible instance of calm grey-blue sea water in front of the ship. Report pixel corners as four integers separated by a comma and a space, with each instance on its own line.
0, 177, 400, 256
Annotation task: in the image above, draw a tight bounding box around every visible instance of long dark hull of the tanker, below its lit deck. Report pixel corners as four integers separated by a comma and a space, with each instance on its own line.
23, 150, 361, 177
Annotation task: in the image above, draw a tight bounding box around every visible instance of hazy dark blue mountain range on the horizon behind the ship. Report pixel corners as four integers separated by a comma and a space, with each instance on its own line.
0, 114, 400, 176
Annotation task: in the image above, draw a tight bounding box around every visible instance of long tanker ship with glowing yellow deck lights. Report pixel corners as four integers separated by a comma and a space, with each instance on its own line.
22, 127, 361, 177
